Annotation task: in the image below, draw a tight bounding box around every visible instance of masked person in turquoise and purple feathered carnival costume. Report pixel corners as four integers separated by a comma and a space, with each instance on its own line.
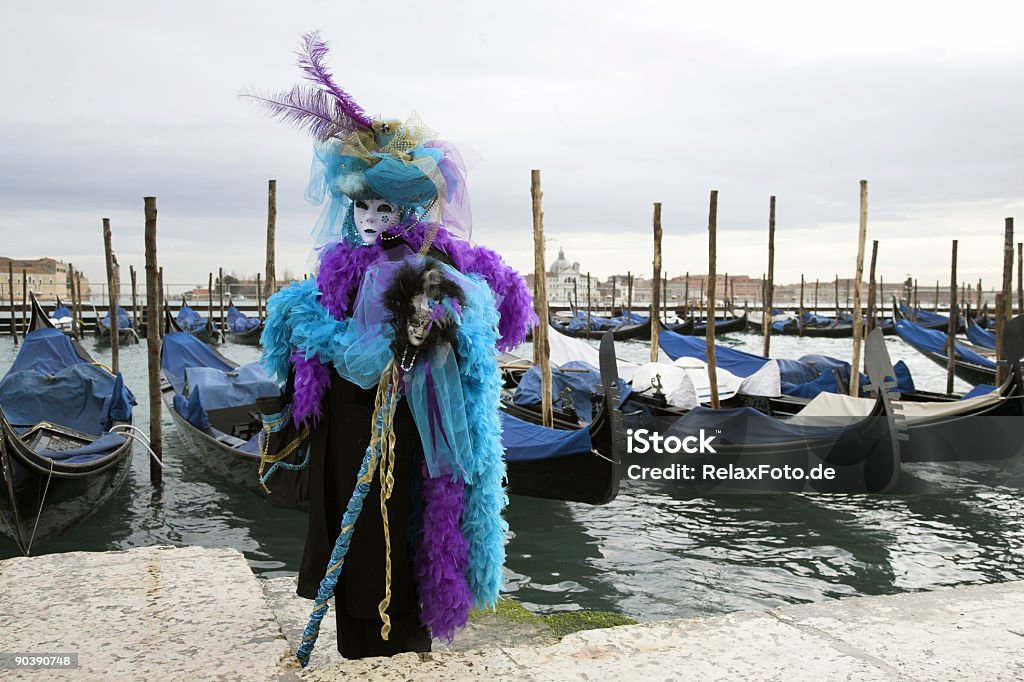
251, 34, 536, 657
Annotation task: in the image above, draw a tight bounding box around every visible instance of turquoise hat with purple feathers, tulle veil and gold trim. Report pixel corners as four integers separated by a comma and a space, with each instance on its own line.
246, 32, 472, 247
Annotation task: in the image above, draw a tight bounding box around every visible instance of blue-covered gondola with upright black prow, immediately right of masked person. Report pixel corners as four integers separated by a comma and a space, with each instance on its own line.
502, 331, 626, 505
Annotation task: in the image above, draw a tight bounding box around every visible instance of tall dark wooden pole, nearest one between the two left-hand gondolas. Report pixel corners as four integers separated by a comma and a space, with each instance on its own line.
142, 197, 164, 485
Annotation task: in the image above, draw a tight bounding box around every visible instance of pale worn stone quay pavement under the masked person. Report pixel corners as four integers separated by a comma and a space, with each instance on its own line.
0, 547, 1024, 680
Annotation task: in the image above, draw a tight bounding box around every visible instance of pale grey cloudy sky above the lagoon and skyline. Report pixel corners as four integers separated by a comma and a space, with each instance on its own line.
0, 0, 1024, 288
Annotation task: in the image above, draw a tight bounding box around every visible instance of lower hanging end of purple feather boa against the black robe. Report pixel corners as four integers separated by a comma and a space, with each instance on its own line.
416, 464, 474, 642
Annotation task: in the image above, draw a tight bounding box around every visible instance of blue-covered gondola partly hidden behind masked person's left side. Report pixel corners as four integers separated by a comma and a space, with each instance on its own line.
160, 307, 280, 496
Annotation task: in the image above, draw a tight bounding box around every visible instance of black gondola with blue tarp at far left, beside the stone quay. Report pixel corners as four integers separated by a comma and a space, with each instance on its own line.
0, 297, 134, 555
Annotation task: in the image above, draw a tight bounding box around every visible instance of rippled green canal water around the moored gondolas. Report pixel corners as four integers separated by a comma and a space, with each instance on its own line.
0, 334, 1024, 621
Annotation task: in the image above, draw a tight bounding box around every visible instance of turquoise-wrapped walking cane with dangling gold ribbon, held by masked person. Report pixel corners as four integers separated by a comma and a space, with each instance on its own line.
295, 358, 401, 668
